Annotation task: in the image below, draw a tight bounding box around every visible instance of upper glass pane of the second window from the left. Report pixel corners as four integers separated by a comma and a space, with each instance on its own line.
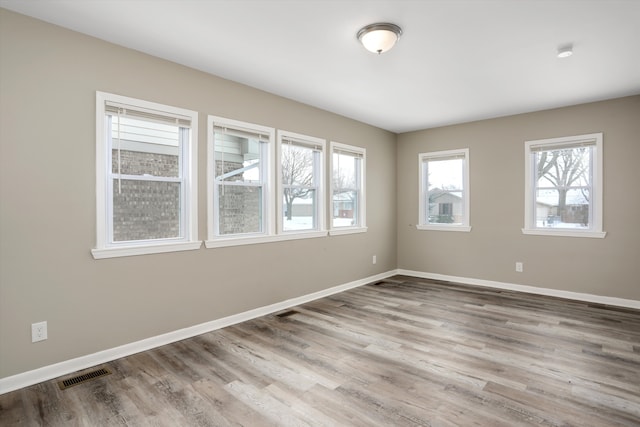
214, 133, 264, 183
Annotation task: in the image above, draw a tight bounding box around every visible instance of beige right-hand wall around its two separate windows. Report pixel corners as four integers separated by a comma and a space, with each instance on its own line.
397, 96, 640, 300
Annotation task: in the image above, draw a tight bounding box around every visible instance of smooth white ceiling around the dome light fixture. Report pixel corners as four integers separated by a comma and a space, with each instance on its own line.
0, 0, 640, 133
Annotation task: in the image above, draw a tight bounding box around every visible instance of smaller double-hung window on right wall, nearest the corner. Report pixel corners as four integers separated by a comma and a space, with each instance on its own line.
417, 148, 471, 231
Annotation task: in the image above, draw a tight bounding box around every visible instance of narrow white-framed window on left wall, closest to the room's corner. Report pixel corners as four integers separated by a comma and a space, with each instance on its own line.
330, 142, 367, 234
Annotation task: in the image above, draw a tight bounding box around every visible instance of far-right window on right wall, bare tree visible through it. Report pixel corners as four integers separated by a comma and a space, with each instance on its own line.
522, 133, 606, 237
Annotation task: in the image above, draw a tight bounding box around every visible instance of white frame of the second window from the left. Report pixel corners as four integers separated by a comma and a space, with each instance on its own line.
205, 115, 277, 248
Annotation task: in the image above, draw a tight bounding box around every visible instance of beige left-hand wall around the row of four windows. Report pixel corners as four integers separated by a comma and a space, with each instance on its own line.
0, 9, 396, 378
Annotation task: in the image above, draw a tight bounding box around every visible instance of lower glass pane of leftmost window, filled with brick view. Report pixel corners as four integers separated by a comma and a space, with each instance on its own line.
113, 179, 180, 242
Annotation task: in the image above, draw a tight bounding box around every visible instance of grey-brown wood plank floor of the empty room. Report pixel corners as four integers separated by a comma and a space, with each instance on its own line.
0, 276, 640, 427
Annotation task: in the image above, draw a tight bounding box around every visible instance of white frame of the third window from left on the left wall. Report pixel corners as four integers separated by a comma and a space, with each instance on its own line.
276, 130, 327, 239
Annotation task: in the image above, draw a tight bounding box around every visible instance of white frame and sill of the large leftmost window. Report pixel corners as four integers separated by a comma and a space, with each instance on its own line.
91, 91, 202, 259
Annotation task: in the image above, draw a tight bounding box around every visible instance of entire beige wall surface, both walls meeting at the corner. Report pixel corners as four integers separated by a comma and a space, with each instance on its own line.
0, 9, 640, 378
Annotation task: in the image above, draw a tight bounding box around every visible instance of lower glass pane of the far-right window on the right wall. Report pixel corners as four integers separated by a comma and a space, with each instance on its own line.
535, 188, 590, 229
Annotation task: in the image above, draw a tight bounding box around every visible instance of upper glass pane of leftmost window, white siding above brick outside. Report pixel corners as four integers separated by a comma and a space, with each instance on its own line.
111, 116, 180, 177
